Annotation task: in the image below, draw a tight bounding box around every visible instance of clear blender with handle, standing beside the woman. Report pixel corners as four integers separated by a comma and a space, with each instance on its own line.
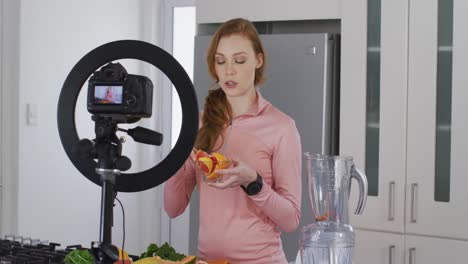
299, 153, 367, 264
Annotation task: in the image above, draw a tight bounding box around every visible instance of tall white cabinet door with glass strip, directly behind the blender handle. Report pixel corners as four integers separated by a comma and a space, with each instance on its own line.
340, 0, 408, 233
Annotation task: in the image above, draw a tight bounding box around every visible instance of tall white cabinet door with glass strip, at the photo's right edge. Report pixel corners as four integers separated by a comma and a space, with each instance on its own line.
406, 0, 468, 240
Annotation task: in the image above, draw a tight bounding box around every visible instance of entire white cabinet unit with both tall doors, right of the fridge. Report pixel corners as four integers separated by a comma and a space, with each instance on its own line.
340, 0, 468, 264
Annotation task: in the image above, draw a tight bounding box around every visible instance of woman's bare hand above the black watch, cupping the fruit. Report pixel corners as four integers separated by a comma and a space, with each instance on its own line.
208, 161, 257, 189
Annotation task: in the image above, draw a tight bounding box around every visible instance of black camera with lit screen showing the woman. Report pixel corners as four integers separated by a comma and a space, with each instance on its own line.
87, 62, 153, 120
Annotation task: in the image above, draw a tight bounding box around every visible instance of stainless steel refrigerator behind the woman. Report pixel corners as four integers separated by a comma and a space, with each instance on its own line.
189, 33, 340, 261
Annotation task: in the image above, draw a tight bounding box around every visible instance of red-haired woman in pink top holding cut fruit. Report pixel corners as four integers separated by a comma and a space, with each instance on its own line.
164, 19, 301, 264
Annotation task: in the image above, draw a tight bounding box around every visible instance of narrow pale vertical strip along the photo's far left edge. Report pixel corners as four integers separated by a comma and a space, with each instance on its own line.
0, 0, 20, 237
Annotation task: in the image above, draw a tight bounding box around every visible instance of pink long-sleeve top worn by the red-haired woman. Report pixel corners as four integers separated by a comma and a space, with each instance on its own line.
164, 92, 302, 264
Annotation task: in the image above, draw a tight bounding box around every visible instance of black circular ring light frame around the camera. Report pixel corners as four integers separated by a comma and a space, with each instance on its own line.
57, 40, 199, 192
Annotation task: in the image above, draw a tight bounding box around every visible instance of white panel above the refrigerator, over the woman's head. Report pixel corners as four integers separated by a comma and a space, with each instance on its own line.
196, 0, 342, 23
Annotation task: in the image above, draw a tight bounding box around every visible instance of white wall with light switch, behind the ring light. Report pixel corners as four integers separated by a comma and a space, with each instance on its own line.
16, 0, 165, 254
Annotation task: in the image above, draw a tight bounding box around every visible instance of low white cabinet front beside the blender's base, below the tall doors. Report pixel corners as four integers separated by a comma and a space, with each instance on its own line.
353, 230, 405, 264
